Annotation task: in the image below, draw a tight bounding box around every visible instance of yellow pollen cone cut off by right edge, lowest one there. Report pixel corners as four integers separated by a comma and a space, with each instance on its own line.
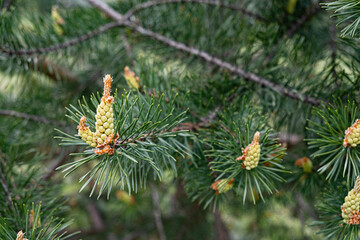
341, 177, 360, 225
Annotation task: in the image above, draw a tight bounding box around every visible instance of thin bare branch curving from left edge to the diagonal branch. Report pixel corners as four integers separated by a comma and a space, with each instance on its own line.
0, 22, 121, 56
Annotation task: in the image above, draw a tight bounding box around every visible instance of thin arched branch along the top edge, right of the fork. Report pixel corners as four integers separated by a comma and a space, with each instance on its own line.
124, 0, 266, 21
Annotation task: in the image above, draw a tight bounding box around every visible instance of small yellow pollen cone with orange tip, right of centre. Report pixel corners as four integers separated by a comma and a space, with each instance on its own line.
236, 132, 261, 170
